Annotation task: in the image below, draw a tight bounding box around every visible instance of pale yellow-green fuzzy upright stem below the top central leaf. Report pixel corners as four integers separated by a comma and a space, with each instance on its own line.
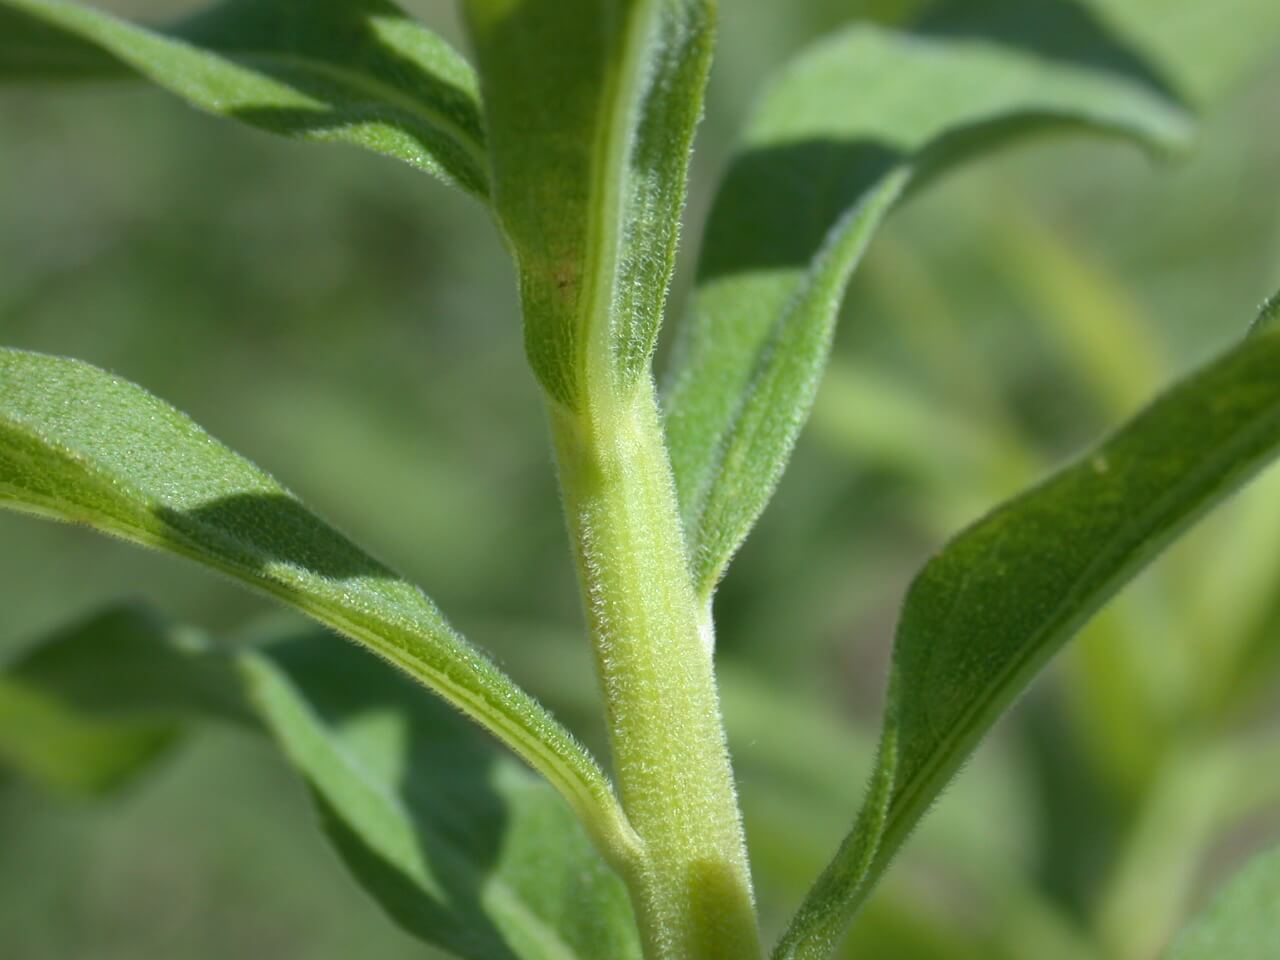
552, 378, 760, 960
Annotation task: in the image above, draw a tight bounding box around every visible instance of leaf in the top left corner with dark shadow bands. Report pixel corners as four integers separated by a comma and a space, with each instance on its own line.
0, 0, 488, 197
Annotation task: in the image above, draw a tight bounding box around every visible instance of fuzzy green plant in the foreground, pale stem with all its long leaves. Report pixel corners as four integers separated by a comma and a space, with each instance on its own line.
0, 0, 1280, 960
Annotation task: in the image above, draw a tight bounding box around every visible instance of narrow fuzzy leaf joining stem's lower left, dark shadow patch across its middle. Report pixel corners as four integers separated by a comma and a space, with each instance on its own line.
0, 349, 632, 861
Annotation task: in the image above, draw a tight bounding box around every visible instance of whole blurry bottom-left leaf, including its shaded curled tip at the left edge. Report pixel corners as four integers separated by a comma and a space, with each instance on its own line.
0, 607, 640, 960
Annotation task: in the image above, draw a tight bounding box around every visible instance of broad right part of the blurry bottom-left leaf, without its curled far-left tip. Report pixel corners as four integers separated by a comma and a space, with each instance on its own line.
244, 635, 640, 960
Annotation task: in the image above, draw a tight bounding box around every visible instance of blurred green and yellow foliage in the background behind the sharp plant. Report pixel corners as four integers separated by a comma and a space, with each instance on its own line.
0, 0, 1280, 960
